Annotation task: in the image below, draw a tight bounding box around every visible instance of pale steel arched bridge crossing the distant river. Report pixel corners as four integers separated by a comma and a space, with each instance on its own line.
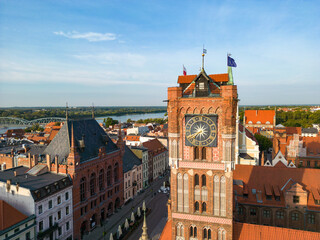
0, 117, 66, 127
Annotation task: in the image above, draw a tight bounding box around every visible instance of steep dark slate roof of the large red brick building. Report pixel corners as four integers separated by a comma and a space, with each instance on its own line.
43, 119, 118, 164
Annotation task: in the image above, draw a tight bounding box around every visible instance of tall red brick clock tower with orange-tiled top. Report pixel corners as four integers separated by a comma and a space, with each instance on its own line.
168, 59, 238, 240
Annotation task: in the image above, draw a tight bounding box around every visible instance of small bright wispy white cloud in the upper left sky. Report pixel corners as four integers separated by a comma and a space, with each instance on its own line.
54, 31, 117, 42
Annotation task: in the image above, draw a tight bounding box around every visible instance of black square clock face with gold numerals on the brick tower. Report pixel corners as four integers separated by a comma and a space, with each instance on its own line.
185, 115, 218, 147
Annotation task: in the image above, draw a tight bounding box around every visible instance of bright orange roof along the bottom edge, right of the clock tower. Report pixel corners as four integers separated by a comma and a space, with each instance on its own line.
233, 222, 320, 240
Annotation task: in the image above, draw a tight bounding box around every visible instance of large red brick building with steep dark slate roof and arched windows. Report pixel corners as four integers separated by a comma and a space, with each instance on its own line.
39, 119, 124, 239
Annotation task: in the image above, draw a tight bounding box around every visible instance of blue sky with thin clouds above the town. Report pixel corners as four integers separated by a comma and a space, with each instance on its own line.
0, 0, 320, 107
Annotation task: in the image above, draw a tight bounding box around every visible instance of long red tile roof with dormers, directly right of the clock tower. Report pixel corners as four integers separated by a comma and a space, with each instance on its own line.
233, 165, 320, 211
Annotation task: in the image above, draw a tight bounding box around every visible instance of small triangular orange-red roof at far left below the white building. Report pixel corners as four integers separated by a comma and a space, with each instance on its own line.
0, 200, 27, 231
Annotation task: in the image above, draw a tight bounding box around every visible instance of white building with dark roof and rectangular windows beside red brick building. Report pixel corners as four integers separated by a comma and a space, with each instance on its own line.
0, 166, 73, 240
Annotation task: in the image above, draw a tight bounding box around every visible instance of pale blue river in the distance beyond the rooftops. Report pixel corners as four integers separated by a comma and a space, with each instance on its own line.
0, 112, 165, 134
